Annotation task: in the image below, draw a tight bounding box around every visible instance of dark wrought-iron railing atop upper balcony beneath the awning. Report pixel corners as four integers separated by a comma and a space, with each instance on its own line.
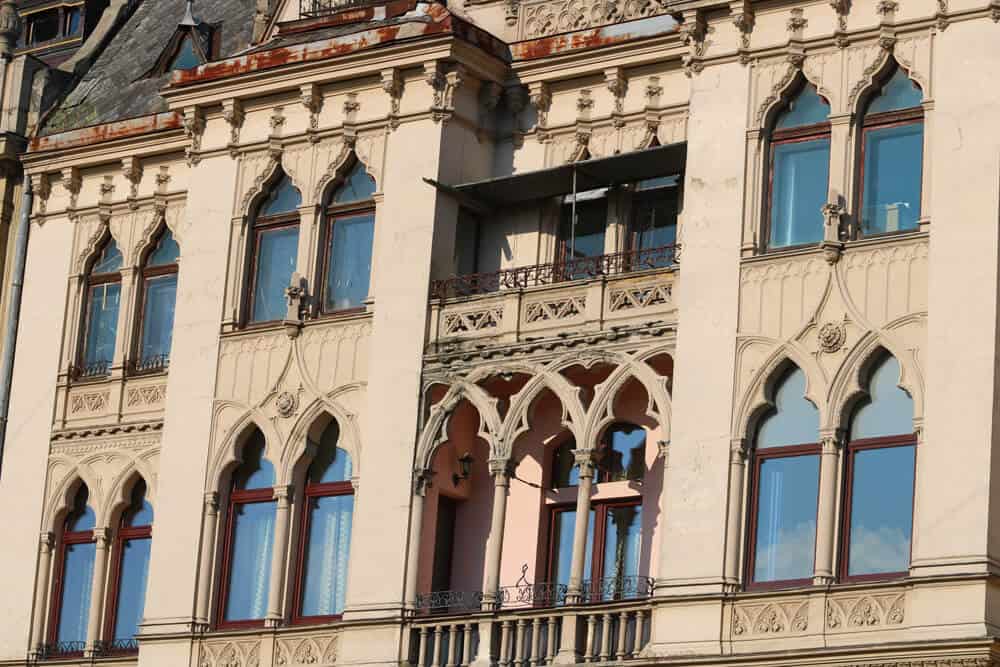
430, 245, 677, 299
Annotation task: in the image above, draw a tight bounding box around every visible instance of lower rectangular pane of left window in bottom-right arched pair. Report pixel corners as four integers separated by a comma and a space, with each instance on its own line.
753, 456, 819, 582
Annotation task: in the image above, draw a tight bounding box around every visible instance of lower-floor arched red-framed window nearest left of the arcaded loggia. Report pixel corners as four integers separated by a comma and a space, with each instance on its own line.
295, 421, 354, 623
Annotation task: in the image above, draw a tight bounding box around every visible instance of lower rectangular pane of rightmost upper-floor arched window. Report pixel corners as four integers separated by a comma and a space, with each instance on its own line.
861, 122, 924, 234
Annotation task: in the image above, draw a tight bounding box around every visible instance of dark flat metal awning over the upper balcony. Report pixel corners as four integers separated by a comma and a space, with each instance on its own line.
424, 143, 687, 209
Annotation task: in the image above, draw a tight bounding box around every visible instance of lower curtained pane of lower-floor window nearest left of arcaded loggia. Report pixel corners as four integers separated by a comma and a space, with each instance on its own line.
302, 496, 354, 616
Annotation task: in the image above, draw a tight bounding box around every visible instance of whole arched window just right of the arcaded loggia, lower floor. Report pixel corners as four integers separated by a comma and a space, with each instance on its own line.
747, 368, 820, 587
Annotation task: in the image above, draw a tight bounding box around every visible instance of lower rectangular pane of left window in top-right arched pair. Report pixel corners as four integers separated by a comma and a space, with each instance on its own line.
770, 139, 830, 248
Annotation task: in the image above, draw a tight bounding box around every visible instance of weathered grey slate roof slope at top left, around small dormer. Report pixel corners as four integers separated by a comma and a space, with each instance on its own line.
40, 0, 256, 136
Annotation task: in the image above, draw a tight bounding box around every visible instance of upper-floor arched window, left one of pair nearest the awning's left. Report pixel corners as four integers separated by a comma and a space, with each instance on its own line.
247, 174, 302, 322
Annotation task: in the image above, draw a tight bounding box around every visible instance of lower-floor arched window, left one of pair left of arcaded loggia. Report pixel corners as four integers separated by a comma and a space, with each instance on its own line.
218, 429, 277, 627
